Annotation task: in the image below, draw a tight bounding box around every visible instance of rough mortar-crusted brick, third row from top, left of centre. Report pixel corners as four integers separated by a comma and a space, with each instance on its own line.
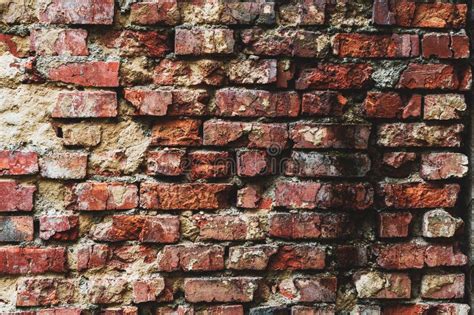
153, 59, 227, 86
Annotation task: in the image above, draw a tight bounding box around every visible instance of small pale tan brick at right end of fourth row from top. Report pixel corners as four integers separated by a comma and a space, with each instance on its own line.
423, 94, 467, 120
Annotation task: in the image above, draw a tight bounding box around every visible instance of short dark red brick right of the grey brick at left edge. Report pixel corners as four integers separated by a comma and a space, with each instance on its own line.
39, 215, 79, 241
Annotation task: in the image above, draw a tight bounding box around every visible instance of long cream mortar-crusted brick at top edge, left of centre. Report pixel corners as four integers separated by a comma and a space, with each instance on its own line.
181, 0, 275, 25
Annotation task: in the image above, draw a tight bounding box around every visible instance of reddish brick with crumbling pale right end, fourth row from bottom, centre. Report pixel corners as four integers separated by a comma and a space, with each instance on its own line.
192, 214, 265, 241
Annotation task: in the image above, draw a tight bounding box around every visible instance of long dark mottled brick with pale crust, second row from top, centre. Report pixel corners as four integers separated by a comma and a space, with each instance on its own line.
241, 28, 330, 58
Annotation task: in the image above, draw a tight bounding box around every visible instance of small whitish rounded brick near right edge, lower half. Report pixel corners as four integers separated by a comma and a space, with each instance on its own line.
422, 209, 464, 238
